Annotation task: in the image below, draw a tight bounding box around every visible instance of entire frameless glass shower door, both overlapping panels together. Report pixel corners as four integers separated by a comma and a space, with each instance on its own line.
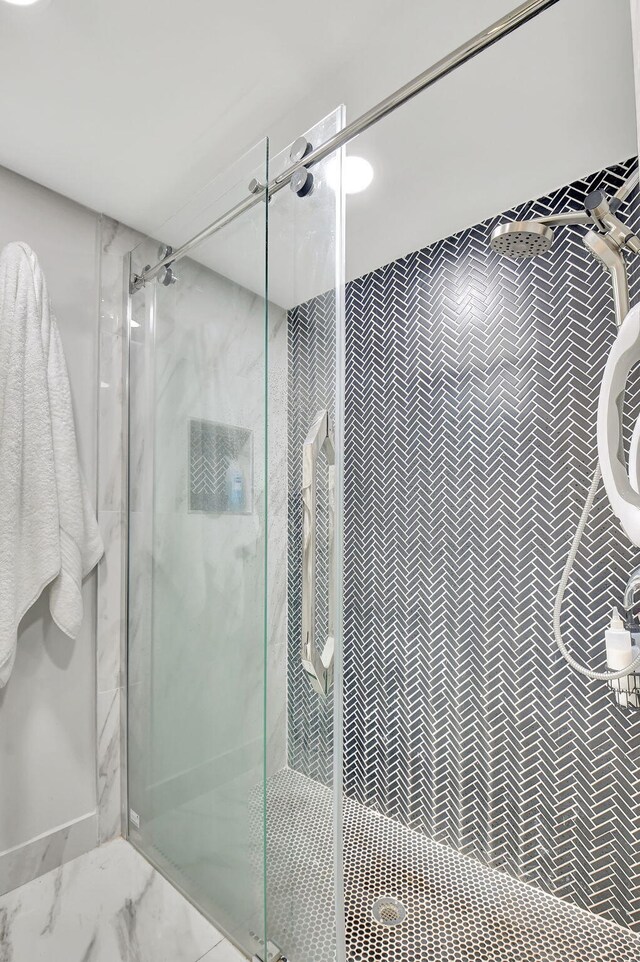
127, 110, 343, 962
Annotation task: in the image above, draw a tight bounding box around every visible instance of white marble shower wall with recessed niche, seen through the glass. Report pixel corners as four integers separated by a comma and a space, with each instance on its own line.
129, 240, 287, 804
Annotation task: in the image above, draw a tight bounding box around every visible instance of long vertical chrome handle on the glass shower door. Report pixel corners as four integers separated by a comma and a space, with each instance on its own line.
302, 411, 335, 695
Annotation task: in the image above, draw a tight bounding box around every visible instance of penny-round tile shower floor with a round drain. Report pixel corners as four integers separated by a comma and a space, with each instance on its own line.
268, 771, 640, 962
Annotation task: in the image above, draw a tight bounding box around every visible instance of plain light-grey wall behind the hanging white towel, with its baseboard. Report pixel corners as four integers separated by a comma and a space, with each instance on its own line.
0, 161, 99, 891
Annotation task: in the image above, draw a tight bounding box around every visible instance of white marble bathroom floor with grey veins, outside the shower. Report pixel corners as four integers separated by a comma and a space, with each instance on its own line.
0, 839, 246, 962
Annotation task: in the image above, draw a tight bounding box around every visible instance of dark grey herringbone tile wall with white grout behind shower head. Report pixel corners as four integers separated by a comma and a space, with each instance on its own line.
289, 161, 640, 930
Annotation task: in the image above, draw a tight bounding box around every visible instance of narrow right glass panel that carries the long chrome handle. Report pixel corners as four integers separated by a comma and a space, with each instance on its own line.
266, 109, 344, 962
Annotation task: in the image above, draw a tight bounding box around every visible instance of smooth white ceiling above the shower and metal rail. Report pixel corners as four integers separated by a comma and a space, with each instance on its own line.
0, 0, 637, 303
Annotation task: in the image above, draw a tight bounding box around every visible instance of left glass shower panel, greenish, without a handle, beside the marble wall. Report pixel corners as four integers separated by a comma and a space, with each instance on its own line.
128, 144, 267, 955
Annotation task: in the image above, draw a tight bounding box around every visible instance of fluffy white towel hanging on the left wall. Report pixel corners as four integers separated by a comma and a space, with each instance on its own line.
0, 243, 104, 687
